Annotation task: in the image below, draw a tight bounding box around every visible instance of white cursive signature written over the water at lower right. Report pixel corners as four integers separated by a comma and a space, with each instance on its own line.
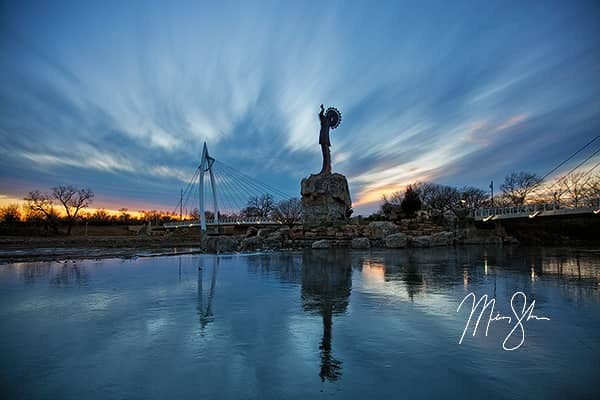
456, 292, 550, 351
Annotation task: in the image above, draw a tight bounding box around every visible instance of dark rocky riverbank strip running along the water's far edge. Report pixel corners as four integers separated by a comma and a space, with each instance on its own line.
0, 219, 600, 264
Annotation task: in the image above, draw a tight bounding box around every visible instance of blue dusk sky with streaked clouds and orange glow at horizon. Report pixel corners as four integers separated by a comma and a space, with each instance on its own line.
0, 1, 600, 214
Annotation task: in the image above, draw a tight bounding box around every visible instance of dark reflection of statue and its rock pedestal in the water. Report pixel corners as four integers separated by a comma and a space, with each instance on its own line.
302, 249, 352, 381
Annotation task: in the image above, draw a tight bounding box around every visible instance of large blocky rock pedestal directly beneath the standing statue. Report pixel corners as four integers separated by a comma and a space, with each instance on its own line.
300, 173, 352, 228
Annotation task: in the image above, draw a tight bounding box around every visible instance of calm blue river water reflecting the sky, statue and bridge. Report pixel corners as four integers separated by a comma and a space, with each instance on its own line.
0, 247, 600, 400
